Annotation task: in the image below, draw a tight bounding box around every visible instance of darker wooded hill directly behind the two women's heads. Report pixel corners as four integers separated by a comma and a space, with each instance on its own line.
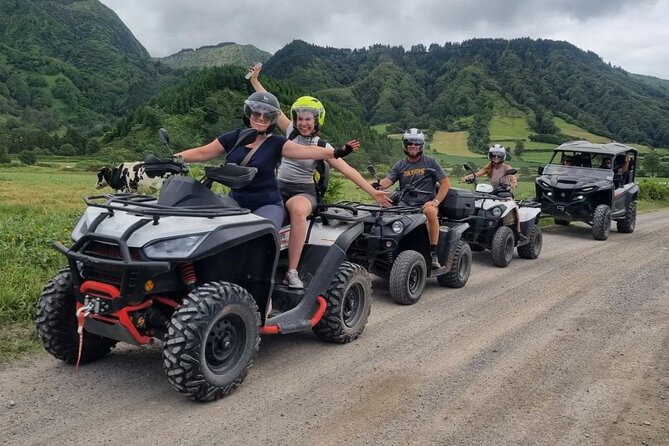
103, 66, 397, 167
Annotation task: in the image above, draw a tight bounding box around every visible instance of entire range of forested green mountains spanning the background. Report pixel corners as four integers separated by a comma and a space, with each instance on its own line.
0, 0, 669, 166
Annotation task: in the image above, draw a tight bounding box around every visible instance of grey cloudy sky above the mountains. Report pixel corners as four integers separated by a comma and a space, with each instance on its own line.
101, 0, 669, 79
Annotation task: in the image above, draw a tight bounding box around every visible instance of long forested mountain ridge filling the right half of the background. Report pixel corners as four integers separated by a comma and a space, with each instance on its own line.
263, 38, 669, 147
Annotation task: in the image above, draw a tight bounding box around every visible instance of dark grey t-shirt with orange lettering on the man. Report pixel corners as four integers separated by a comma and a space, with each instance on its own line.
388, 155, 447, 206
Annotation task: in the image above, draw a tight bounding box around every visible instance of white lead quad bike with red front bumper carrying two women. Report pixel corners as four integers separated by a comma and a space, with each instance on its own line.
36, 129, 372, 401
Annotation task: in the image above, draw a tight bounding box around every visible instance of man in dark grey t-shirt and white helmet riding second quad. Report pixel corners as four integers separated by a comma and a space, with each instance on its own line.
379, 128, 451, 269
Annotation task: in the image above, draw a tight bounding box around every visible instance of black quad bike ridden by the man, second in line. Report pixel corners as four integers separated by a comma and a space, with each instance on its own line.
345, 166, 471, 305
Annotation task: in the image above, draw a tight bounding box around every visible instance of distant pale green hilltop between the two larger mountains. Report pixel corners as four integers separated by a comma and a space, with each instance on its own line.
158, 42, 272, 68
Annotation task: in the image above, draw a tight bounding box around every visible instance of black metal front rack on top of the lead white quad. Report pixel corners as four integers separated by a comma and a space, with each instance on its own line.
84, 193, 251, 220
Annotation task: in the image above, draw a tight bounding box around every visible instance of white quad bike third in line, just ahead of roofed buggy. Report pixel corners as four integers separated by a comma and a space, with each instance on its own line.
442, 164, 543, 267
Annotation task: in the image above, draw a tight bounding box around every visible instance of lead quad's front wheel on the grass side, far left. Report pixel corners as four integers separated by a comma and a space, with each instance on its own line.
35, 269, 116, 364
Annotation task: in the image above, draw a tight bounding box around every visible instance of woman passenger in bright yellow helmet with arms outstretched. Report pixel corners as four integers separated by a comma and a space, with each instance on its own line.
250, 66, 392, 289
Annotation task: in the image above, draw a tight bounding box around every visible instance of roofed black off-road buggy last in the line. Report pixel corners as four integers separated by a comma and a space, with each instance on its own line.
535, 141, 639, 240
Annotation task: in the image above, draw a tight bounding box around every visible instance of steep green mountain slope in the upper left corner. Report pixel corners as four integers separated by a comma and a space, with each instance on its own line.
0, 0, 180, 153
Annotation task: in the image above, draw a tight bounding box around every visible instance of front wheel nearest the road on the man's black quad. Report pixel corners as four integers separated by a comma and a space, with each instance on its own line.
388, 249, 427, 305
